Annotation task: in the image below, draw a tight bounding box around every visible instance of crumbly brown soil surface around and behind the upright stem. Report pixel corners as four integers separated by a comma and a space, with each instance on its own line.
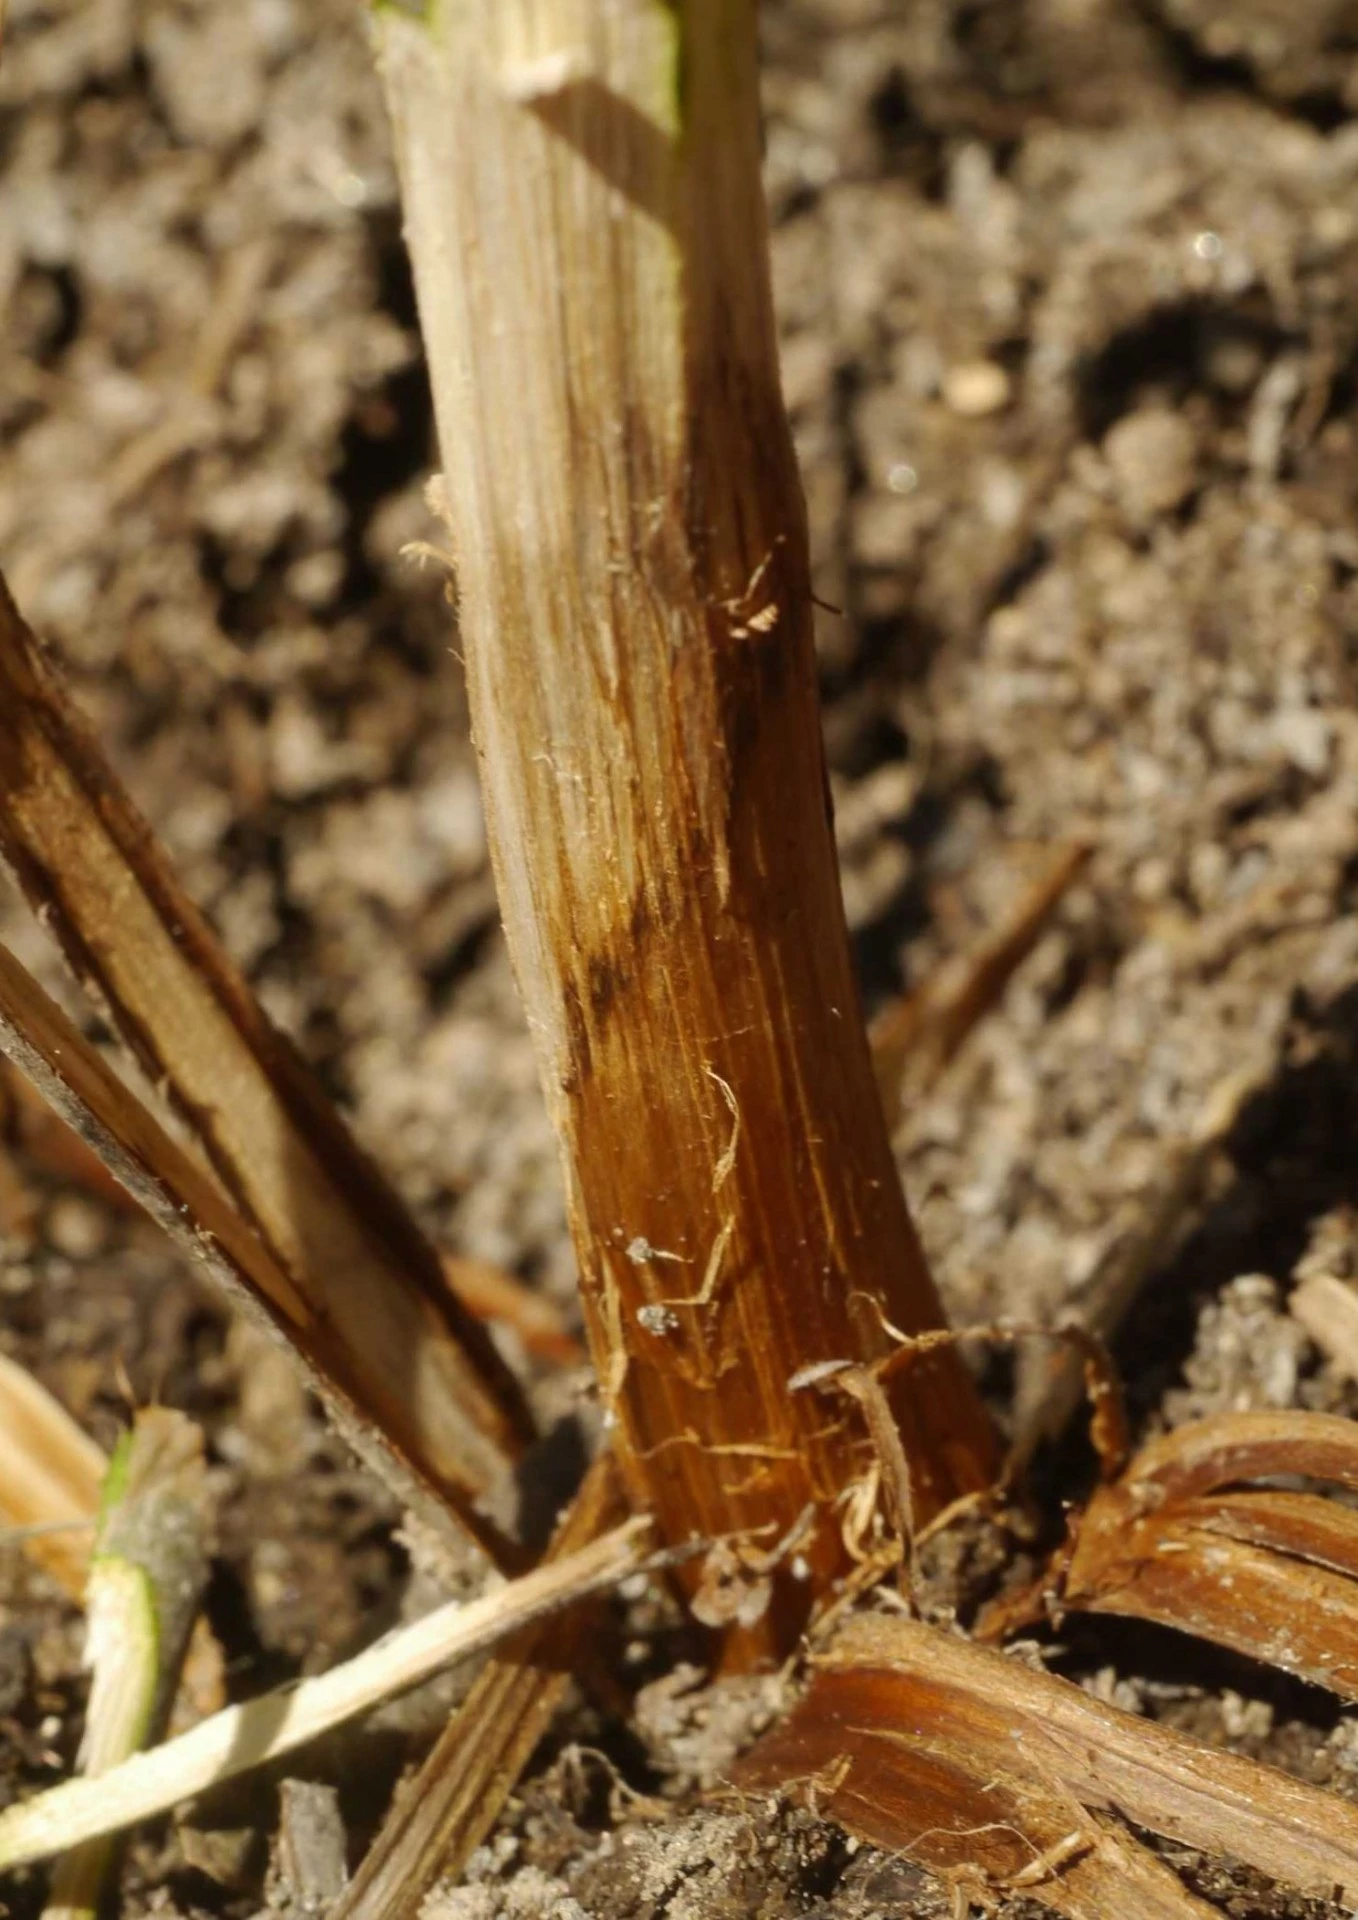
0, 0, 1358, 1920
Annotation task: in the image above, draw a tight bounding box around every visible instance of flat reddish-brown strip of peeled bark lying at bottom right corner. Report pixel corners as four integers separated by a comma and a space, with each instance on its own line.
738, 1619, 1358, 1920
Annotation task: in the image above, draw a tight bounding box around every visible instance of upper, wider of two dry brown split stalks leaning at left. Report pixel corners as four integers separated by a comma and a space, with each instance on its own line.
0, 586, 526, 1559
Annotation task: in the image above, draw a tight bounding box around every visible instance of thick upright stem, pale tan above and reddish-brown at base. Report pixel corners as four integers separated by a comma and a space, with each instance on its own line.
376, 0, 991, 1619
